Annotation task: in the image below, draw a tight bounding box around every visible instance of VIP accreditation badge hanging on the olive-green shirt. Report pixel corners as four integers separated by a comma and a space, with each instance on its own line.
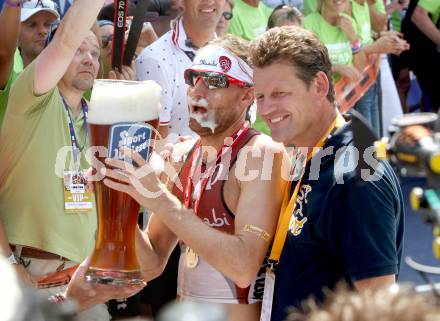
63, 171, 93, 214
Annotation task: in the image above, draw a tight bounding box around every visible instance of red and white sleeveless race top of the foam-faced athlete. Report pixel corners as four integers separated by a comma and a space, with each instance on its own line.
173, 125, 265, 304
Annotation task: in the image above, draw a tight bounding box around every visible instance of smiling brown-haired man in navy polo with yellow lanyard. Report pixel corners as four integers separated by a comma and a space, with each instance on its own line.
251, 27, 404, 321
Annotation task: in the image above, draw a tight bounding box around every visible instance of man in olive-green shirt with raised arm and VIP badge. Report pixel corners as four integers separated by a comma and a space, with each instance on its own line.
0, 0, 143, 321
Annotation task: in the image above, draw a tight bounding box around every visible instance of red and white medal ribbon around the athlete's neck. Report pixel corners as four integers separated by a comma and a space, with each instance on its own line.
183, 122, 249, 214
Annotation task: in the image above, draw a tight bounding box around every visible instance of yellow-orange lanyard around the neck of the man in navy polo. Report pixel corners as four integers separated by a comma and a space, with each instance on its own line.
269, 113, 346, 264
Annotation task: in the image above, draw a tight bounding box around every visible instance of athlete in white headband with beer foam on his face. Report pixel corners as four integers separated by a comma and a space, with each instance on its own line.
104, 36, 284, 321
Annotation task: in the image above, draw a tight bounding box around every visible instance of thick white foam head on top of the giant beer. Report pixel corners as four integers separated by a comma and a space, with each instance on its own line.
88, 80, 162, 125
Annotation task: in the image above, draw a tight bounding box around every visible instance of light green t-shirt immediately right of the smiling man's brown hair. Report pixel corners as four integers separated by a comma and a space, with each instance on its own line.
304, 12, 353, 82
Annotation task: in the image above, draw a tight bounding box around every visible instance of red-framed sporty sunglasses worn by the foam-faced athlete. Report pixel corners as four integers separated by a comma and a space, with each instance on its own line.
184, 69, 253, 89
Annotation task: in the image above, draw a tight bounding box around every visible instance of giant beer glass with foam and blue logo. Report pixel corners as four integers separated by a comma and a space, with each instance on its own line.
86, 80, 161, 284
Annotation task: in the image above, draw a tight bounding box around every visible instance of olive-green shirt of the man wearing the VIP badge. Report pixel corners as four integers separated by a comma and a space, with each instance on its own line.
0, 63, 96, 262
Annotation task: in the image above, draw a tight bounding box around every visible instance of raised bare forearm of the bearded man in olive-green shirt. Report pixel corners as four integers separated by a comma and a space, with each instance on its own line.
34, 0, 104, 96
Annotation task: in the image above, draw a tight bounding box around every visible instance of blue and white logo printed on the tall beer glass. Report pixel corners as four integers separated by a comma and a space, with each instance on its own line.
108, 123, 153, 160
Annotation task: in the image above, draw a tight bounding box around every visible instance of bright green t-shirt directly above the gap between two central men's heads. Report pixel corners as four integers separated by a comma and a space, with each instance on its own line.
228, 0, 273, 40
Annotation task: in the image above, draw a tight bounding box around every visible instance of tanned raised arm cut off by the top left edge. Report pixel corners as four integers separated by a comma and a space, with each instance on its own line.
0, 0, 21, 90
